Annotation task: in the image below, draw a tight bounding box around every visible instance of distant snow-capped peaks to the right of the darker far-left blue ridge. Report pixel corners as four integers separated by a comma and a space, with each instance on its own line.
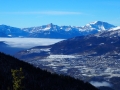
23, 21, 115, 38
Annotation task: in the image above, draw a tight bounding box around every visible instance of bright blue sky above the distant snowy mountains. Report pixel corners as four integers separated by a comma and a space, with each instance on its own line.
0, 0, 120, 28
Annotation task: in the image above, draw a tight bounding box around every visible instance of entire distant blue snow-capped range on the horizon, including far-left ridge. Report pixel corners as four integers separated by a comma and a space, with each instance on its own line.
0, 21, 116, 38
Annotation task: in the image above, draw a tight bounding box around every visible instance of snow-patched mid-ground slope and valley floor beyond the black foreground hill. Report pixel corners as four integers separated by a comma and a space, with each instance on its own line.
15, 27, 120, 90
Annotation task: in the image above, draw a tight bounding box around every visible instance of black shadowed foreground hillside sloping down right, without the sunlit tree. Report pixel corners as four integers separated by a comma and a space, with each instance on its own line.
0, 53, 98, 90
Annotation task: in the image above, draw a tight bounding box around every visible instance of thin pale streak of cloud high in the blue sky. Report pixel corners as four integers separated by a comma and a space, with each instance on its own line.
0, 11, 82, 15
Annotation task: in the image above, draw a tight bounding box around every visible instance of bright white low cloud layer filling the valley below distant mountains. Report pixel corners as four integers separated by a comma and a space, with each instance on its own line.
0, 38, 63, 48
